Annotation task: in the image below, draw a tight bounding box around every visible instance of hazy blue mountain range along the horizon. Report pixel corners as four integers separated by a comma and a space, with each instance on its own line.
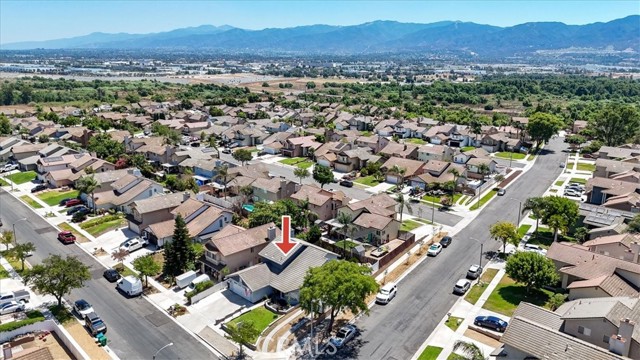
1, 15, 640, 56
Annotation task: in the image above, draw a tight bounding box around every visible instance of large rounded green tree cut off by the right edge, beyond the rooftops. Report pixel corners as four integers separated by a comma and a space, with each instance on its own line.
589, 103, 640, 146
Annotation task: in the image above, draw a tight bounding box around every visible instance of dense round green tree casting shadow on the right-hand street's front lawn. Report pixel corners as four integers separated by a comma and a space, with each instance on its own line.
505, 251, 560, 292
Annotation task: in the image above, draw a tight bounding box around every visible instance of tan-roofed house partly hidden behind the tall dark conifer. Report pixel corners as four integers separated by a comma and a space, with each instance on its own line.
143, 199, 233, 247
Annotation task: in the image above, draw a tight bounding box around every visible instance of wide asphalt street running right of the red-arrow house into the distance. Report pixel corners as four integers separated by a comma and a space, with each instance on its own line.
348, 139, 567, 360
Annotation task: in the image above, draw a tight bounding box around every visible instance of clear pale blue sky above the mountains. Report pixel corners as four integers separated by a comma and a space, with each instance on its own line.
0, 0, 640, 44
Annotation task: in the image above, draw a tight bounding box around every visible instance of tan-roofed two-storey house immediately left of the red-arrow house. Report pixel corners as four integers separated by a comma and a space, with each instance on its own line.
200, 223, 281, 280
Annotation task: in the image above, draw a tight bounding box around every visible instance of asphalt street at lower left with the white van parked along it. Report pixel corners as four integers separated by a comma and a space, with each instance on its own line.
0, 190, 217, 360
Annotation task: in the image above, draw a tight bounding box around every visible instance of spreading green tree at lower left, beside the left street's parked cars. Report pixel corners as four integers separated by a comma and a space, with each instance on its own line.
22, 255, 91, 306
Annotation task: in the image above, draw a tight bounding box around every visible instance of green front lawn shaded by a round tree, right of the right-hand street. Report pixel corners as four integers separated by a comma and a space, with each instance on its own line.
482, 276, 553, 316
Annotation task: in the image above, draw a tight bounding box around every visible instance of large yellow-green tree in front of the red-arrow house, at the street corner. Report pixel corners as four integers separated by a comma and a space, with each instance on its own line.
300, 260, 378, 332
